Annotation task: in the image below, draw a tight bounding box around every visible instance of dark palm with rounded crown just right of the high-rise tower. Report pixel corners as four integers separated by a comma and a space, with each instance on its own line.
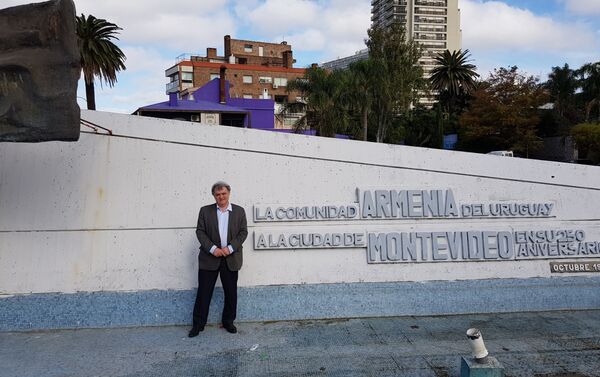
429, 50, 479, 112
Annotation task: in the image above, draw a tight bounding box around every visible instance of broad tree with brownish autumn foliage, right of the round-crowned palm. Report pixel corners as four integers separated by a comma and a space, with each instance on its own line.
459, 67, 548, 156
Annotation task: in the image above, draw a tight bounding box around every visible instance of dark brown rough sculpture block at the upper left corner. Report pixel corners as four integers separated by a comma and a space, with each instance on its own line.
0, 0, 81, 142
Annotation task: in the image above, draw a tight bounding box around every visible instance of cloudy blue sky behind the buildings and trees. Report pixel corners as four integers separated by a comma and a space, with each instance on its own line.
0, 0, 600, 113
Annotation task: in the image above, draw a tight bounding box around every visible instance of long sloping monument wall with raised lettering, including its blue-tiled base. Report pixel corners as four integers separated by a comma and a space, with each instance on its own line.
0, 111, 600, 330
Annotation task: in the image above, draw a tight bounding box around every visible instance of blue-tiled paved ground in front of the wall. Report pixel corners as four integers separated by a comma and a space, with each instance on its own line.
0, 310, 600, 377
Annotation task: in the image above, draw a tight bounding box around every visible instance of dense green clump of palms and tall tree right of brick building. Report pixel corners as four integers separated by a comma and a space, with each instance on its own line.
282, 24, 426, 142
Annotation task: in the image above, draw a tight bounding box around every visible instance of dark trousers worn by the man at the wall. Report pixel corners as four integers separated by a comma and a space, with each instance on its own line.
194, 258, 238, 326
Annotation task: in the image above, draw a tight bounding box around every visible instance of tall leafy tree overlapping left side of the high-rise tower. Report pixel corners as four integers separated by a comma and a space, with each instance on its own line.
365, 23, 426, 142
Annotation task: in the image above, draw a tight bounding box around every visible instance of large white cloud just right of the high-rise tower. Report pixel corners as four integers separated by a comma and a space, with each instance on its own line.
460, 0, 597, 53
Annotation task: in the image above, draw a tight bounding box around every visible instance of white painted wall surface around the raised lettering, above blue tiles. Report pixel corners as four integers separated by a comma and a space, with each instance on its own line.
0, 111, 600, 295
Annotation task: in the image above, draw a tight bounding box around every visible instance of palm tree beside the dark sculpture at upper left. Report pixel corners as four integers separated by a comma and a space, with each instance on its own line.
75, 14, 125, 110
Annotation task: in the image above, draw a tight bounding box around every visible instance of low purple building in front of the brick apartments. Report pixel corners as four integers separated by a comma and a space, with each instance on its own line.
133, 69, 275, 130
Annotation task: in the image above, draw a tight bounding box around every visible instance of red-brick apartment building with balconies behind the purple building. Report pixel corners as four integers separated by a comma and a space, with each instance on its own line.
165, 35, 305, 128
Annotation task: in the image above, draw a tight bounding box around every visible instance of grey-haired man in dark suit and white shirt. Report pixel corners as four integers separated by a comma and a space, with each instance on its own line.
188, 181, 248, 338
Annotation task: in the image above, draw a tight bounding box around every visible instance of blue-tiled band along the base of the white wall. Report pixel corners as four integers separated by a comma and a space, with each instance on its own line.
0, 277, 600, 331
